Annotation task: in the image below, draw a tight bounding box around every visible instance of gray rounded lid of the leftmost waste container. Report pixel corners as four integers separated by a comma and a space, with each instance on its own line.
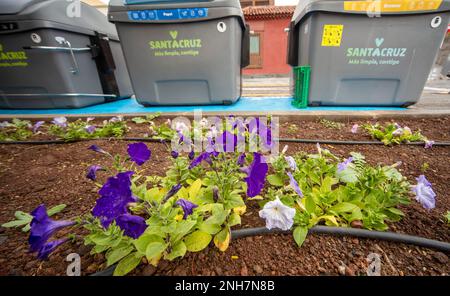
0, 0, 118, 40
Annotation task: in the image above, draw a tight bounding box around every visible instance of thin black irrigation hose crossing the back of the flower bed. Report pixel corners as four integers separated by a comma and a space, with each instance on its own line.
0, 137, 450, 146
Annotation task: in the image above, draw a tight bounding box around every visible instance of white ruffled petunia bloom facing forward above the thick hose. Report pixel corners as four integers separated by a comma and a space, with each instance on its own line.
259, 197, 295, 231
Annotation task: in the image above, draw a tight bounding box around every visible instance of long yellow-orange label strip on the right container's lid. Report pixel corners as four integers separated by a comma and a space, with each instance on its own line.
344, 0, 442, 13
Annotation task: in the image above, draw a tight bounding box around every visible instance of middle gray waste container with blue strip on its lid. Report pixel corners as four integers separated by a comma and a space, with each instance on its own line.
108, 0, 249, 106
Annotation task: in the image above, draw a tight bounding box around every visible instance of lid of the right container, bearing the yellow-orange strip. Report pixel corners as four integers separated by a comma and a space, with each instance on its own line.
292, 0, 450, 24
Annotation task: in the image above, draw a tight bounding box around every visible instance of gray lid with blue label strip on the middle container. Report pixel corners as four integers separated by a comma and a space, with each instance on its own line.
108, 0, 245, 24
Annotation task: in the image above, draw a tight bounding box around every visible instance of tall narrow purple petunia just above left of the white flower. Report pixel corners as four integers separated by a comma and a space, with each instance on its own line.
244, 152, 269, 197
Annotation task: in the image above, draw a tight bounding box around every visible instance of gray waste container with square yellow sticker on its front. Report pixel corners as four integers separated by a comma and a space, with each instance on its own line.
288, 0, 450, 106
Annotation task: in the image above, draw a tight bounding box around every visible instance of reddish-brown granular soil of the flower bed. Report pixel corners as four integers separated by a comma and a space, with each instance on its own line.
0, 118, 450, 275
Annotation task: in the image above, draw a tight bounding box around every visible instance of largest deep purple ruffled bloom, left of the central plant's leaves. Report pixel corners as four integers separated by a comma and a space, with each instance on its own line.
92, 172, 136, 228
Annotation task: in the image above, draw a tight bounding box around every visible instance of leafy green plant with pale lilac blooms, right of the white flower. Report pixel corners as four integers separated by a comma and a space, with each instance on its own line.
261, 146, 410, 245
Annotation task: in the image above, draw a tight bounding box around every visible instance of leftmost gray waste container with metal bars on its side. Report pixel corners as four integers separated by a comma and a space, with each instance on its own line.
0, 0, 132, 109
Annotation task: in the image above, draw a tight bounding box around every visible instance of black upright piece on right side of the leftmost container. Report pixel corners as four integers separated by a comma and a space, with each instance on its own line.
90, 32, 120, 102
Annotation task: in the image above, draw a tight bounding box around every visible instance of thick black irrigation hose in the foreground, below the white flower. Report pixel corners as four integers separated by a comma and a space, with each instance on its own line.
91, 226, 450, 276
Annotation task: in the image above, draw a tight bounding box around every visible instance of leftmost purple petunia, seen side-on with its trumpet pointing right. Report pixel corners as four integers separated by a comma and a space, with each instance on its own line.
28, 205, 75, 252
